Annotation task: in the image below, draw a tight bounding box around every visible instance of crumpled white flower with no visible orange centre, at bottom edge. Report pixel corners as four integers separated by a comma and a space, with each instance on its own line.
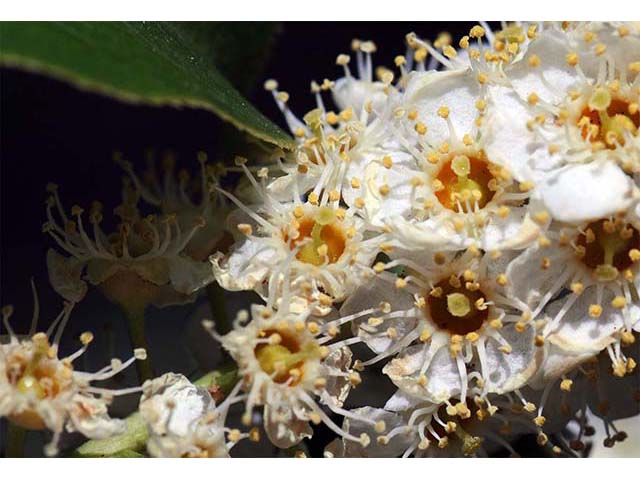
140, 373, 248, 458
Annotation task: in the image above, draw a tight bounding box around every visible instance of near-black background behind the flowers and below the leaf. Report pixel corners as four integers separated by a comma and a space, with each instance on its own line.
0, 22, 540, 456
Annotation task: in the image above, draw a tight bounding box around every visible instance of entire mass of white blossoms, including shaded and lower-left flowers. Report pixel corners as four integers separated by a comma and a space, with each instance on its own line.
5, 22, 640, 457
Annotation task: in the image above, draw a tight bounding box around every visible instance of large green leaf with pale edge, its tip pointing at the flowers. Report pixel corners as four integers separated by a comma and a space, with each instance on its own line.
0, 22, 293, 148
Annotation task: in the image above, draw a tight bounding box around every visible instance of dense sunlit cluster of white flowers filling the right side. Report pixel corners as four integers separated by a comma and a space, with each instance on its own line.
212, 23, 640, 456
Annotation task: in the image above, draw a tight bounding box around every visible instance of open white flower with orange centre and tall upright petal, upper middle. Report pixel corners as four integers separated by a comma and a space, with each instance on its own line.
365, 69, 544, 250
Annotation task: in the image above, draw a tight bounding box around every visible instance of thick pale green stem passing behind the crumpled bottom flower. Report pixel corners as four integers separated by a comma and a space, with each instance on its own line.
72, 364, 238, 457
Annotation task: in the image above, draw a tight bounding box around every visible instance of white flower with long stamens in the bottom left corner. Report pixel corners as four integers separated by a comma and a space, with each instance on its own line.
0, 298, 146, 456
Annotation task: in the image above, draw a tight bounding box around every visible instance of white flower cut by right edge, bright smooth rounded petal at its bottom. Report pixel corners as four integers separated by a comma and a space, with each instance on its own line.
486, 25, 640, 222
